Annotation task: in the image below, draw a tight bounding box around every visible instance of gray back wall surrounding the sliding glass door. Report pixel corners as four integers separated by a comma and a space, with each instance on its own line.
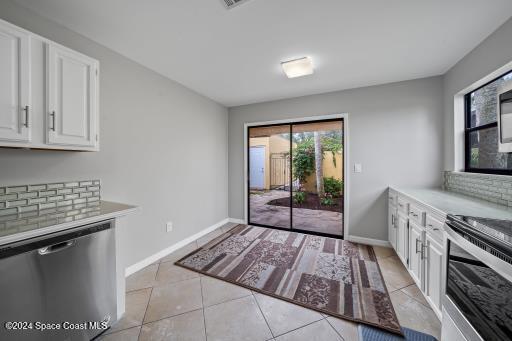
229, 77, 443, 240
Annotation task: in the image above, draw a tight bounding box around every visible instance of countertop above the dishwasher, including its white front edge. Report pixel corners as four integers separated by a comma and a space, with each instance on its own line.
0, 200, 138, 246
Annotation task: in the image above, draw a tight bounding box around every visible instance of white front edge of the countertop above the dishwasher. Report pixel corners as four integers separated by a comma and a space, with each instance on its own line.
0, 200, 140, 246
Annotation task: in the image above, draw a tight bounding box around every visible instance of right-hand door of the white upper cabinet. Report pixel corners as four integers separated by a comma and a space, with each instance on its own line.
47, 44, 98, 147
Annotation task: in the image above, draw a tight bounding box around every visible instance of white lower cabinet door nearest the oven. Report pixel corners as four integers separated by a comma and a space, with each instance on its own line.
425, 235, 443, 316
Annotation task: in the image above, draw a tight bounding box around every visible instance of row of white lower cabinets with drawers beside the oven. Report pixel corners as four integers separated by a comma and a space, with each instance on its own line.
388, 189, 445, 319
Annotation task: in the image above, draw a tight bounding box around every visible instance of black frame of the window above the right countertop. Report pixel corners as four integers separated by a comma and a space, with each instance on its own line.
464, 70, 512, 175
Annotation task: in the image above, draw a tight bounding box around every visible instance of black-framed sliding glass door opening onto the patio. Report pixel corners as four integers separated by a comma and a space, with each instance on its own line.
247, 119, 344, 237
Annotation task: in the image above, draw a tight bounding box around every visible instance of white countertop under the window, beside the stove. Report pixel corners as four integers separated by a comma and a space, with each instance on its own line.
390, 186, 512, 220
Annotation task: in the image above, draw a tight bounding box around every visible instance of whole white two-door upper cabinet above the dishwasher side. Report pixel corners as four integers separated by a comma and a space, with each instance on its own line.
0, 20, 99, 151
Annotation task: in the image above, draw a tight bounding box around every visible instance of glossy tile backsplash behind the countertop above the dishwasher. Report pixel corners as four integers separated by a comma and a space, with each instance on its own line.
0, 180, 101, 216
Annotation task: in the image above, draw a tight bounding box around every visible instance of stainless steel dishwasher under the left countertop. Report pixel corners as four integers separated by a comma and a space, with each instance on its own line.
0, 221, 117, 341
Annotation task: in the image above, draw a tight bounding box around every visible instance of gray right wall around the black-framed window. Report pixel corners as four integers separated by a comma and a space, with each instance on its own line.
444, 18, 512, 170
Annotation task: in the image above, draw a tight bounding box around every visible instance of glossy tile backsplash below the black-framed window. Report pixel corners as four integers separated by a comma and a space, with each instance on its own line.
444, 171, 512, 207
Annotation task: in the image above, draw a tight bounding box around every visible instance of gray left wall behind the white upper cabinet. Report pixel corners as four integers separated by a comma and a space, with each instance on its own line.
0, 0, 228, 265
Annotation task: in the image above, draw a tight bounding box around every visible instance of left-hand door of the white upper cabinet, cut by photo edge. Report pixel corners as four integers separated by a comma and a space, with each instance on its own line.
0, 21, 30, 142
